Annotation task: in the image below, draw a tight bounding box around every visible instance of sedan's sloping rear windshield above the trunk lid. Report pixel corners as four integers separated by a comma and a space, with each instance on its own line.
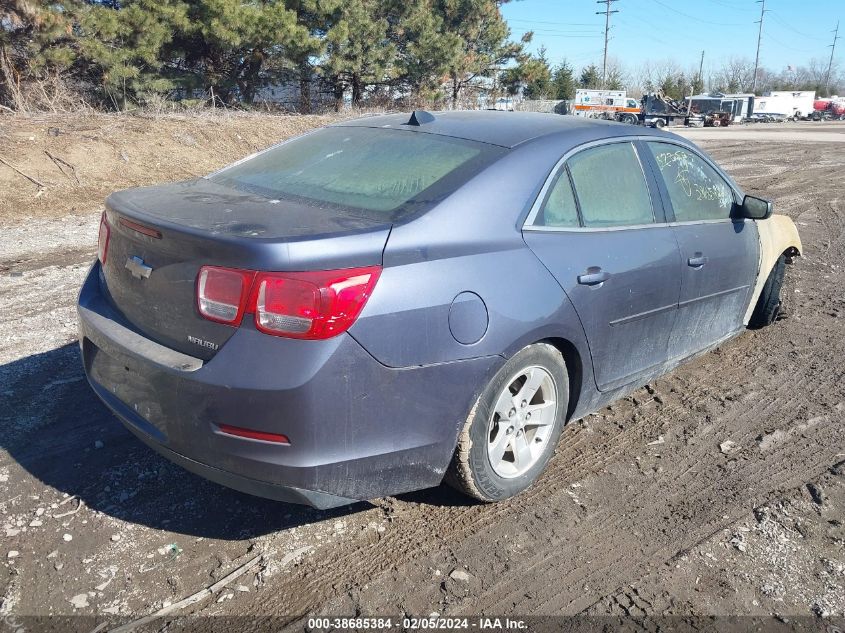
209, 127, 506, 220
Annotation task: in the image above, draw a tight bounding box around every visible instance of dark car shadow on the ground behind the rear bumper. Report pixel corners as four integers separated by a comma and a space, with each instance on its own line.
0, 343, 372, 540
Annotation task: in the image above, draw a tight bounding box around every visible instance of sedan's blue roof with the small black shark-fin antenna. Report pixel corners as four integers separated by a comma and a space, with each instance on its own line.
335, 110, 665, 148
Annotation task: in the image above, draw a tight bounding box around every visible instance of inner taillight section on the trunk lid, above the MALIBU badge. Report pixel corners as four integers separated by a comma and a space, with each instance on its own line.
197, 266, 255, 325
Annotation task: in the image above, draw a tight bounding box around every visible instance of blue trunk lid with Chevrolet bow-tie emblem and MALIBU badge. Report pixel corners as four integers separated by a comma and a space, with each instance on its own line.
101, 178, 391, 360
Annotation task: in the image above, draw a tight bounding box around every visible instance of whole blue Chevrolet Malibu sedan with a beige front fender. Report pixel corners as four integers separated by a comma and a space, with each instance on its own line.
78, 111, 801, 508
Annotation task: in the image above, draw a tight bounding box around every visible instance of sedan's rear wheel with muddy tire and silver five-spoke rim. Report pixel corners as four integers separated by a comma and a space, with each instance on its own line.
446, 343, 569, 502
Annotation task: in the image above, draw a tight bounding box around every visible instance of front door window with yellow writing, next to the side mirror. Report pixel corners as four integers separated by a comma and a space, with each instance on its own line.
646, 141, 734, 222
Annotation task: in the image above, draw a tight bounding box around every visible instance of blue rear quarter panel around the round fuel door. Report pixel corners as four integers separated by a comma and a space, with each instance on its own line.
350, 138, 592, 387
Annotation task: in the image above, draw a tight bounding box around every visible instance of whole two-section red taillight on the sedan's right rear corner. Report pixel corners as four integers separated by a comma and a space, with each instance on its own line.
197, 266, 381, 339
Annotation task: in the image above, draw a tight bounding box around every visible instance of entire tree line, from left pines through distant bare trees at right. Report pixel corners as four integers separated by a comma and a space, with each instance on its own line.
0, 0, 843, 112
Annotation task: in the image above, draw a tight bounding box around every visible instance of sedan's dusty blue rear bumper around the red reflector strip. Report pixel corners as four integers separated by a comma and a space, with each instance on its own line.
78, 265, 502, 508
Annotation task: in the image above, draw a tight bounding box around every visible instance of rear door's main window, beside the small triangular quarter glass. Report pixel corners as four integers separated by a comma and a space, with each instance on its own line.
567, 143, 654, 228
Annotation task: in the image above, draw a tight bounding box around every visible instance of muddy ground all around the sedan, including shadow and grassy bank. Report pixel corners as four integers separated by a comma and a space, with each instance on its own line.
0, 116, 845, 630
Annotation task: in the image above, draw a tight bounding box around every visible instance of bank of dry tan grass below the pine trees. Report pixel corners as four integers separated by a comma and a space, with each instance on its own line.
0, 109, 382, 226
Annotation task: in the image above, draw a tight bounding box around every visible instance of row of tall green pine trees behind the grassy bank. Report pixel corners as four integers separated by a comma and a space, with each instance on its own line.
0, 0, 530, 111
